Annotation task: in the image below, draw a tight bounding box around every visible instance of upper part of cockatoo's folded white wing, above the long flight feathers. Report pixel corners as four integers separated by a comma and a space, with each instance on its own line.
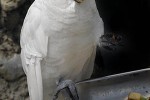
20, 3, 48, 57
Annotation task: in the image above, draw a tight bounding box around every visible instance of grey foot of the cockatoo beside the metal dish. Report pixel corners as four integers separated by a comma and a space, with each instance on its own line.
53, 80, 79, 100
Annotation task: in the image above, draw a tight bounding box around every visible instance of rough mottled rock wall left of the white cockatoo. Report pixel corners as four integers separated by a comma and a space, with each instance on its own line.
0, 0, 33, 100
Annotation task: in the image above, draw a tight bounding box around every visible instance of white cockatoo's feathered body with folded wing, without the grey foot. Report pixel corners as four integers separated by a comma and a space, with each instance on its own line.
20, 0, 104, 100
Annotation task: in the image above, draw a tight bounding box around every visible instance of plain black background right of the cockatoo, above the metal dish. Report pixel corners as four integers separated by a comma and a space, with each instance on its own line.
96, 0, 150, 74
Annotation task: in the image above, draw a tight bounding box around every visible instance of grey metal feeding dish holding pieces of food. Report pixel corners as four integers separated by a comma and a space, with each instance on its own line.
76, 68, 150, 100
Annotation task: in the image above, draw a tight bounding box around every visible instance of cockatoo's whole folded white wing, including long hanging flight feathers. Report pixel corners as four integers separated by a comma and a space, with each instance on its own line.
20, 3, 48, 100
